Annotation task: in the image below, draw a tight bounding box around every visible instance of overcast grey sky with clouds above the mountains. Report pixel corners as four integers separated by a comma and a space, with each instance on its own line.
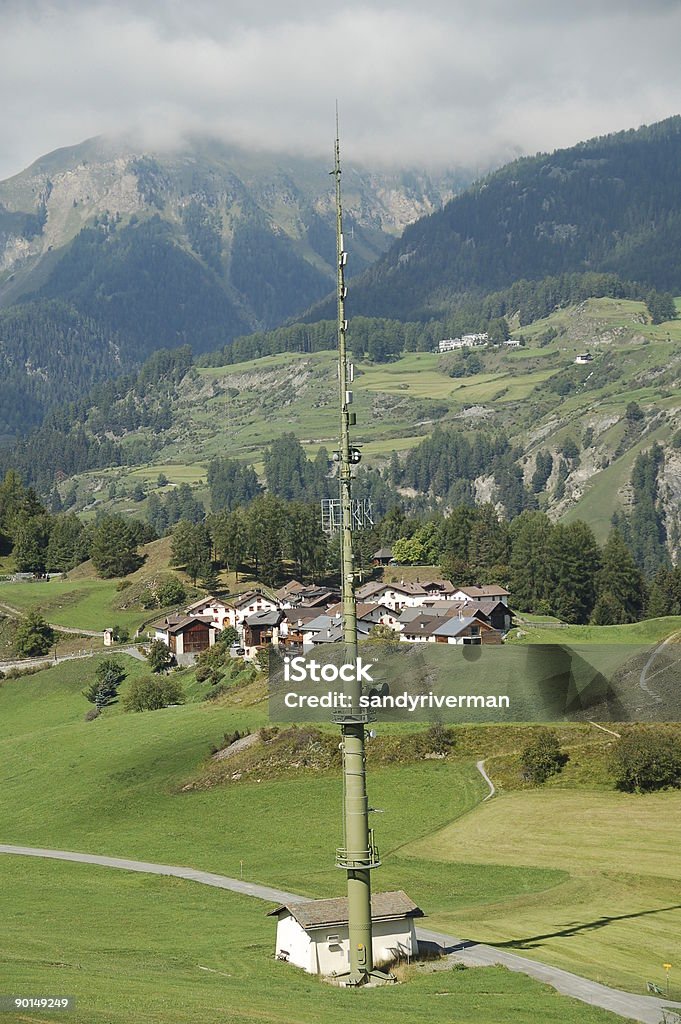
0, 0, 681, 178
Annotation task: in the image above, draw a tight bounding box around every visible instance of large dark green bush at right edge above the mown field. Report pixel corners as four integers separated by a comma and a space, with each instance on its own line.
609, 726, 681, 793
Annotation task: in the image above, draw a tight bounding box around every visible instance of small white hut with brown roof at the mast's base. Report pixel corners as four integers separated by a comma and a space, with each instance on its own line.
267, 890, 424, 977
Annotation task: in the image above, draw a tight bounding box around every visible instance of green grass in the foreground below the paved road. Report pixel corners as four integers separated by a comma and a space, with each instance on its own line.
0, 856, 619, 1024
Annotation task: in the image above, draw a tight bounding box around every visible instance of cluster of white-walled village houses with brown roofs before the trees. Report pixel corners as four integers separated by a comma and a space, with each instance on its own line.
148, 548, 512, 665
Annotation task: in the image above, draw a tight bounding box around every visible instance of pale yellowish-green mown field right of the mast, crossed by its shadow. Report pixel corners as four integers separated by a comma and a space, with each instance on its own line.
405, 790, 681, 998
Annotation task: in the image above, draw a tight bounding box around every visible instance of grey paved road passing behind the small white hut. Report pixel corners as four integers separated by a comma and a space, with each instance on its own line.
0, 844, 681, 1024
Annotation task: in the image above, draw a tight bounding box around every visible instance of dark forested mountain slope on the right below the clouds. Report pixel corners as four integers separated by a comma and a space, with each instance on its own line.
327, 117, 681, 319
